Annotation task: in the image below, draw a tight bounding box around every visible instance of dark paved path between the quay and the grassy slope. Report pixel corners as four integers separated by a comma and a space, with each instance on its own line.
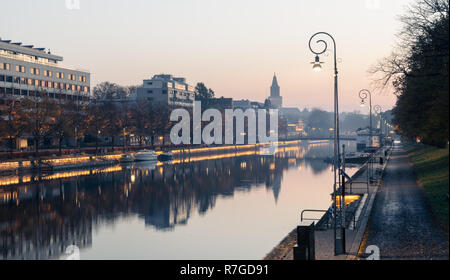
361, 146, 449, 259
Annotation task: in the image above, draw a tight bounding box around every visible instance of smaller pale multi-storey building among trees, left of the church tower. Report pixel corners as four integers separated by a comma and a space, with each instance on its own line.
137, 74, 195, 107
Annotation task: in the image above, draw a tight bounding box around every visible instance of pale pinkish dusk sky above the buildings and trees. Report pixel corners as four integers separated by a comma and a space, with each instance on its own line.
0, 0, 413, 113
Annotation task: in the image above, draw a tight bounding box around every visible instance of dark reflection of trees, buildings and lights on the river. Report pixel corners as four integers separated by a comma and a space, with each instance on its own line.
0, 142, 356, 259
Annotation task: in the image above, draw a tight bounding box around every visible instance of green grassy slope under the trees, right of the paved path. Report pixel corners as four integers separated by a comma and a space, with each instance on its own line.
405, 143, 449, 231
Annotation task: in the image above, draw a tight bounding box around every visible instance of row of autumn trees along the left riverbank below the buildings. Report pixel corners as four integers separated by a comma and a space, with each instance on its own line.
0, 83, 171, 157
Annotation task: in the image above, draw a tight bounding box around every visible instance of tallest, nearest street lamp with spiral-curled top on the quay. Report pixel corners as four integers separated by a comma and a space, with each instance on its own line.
309, 32, 345, 255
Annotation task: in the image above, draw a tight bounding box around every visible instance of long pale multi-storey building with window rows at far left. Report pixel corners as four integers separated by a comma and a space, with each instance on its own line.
0, 39, 90, 104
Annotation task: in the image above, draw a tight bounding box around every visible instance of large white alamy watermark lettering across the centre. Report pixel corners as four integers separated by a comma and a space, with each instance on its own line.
170, 101, 278, 153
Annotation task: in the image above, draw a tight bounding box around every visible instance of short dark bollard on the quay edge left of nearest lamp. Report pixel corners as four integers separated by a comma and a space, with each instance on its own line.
294, 223, 316, 261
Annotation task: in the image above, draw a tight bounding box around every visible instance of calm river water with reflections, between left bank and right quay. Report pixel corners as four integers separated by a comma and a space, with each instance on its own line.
0, 141, 355, 259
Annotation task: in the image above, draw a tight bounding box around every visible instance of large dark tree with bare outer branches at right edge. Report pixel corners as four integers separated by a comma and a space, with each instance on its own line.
369, 0, 449, 147
